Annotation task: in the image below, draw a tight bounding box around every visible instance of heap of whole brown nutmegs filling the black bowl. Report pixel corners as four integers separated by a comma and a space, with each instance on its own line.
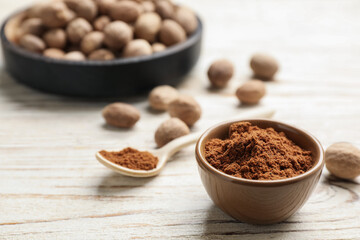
16, 0, 198, 61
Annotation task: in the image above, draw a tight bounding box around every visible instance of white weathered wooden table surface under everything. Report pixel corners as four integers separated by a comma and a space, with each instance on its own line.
0, 0, 360, 239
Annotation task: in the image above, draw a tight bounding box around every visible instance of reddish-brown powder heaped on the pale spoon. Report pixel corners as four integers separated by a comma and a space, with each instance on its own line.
100, 148, 159, 170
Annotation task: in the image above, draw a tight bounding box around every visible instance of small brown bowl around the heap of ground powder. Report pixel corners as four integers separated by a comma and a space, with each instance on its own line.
195, 119, 324, 224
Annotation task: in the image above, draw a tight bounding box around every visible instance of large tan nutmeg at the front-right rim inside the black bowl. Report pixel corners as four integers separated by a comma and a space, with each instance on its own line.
159, 19, 186, 46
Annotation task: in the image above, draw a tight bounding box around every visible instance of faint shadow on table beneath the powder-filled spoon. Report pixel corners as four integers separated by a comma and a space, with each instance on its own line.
97, 173, 154, 195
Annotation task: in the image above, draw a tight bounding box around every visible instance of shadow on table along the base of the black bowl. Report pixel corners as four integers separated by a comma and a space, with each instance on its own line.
0, 67, 147, 112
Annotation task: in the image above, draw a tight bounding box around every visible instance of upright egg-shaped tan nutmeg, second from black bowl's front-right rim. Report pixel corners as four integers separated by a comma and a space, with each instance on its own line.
135, 12, 161, 42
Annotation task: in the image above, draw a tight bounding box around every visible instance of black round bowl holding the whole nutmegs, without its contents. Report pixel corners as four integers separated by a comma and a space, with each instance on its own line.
1, 9, 203, 97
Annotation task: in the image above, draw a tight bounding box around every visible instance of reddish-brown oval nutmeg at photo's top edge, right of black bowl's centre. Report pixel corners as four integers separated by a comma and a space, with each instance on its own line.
109, 0, 141, 23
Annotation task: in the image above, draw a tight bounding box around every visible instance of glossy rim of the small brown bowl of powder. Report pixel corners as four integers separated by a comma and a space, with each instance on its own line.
195, 118, 325, 187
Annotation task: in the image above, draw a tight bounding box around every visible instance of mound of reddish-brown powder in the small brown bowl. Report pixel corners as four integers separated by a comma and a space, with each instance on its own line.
205, 122, 313, 180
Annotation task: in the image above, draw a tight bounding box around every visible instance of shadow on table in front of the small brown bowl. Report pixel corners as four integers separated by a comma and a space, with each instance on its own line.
203, 205, 299, 239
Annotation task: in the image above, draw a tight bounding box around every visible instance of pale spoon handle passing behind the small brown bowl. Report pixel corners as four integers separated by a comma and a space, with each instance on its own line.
159, 108, 275, 159
